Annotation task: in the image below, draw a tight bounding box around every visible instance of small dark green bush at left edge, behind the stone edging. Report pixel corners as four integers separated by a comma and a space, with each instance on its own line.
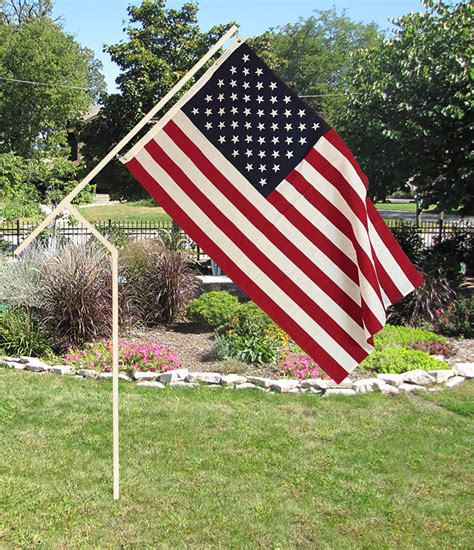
0, 308, 52, 356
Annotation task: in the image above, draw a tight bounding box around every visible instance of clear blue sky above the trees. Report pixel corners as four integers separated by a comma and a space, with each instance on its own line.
53, 0, 422, 92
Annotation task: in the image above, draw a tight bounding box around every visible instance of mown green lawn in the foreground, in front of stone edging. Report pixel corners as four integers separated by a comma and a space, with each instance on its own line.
0, 370, 474, 549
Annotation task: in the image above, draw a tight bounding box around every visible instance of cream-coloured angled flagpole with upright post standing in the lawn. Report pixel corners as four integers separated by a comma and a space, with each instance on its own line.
15, 25, 238, 500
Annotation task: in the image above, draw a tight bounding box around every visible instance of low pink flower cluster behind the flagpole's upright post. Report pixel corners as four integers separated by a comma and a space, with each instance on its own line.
64, 341, 180, 372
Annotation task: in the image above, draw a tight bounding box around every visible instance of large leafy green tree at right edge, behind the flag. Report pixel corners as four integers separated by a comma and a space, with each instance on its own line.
341, 0, 474, 213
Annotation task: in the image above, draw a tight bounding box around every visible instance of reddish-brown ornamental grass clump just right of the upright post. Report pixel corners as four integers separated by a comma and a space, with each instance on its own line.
122, 241, 197, 325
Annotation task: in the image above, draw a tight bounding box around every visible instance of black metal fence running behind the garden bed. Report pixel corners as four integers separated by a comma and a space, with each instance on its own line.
0, 219, 474, 259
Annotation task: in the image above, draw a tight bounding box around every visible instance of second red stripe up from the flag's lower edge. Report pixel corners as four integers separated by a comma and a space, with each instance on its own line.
145, 140, 367, 362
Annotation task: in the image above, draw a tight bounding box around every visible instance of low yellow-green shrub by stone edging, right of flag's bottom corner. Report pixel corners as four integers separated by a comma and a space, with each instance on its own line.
360, 347, 449, 374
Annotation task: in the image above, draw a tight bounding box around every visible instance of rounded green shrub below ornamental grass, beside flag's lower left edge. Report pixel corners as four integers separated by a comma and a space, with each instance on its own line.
186, 292, 240, 328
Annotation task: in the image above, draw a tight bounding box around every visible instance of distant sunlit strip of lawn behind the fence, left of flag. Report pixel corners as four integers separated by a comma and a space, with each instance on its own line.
79, 202, 171, 222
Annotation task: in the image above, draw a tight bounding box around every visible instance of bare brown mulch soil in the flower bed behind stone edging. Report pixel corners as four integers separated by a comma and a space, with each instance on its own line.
123, 322, 474, 380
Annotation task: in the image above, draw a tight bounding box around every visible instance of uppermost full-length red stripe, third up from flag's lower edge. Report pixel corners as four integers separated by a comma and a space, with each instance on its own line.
163, 121, 362, 326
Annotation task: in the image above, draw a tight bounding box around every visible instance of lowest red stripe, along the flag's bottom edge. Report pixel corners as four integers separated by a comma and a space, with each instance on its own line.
126, 158, 349, 383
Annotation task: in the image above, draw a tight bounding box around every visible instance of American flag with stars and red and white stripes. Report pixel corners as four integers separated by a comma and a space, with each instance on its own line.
124, 43, 422, 382
